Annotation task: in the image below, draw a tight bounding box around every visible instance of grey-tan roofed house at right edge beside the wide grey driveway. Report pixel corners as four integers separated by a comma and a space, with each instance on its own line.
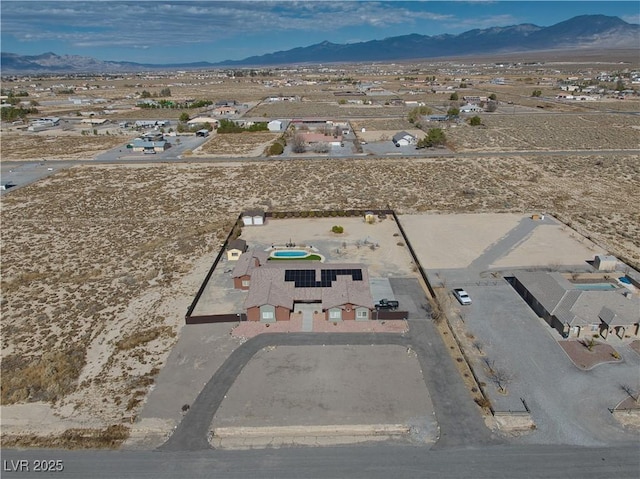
509, 271, 640, 339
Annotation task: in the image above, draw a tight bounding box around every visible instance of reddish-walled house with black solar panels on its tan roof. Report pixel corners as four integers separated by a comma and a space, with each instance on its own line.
232, 250, 374, 322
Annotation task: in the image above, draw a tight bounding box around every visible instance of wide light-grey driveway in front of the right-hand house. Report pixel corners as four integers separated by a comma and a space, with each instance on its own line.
450, 280, 640, 446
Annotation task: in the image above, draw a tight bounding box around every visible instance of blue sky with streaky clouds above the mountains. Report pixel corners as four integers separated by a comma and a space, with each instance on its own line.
0, 0, 640, 63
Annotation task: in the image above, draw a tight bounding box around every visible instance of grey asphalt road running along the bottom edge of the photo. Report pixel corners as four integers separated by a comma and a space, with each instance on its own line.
2, 444, 640, 479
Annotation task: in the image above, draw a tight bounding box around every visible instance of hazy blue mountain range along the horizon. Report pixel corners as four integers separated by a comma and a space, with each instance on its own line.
0, 15, 640, 74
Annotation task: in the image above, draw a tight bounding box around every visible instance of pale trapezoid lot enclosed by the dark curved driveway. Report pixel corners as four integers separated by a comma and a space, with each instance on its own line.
212, 345, 436, 440
